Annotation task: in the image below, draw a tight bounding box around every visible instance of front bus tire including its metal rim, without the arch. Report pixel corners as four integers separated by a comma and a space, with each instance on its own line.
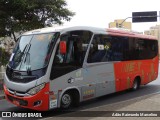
61, 92, 73, 109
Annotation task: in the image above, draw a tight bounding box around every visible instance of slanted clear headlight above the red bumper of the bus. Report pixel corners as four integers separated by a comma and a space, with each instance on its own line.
27, 83, 45, 95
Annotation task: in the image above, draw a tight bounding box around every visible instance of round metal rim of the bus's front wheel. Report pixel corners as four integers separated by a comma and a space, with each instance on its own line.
62, 94, 71, 108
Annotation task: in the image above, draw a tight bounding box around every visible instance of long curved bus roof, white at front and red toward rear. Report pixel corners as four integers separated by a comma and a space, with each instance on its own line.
23, 26, 157, 40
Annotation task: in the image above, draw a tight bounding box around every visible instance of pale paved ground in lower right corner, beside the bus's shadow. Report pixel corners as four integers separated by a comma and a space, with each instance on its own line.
42, 93, 160, 120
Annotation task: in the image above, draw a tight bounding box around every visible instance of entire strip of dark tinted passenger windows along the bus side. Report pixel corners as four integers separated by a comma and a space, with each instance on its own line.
87, 35, 158, 63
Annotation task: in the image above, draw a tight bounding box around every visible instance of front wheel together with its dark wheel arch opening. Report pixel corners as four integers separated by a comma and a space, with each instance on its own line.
61, 89, 80, 109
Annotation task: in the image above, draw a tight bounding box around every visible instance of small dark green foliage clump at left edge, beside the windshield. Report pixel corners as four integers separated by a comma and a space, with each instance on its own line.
0, 48, 10, 66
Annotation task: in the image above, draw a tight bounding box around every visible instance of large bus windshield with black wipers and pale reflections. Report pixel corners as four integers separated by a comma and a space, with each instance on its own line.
9, 33, 59, 71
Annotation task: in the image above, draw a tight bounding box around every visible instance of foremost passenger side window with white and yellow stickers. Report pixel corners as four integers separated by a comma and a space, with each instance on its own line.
87, 35, 113, 63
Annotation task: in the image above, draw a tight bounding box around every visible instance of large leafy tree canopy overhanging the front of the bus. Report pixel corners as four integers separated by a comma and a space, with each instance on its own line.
0, 0, 74, 41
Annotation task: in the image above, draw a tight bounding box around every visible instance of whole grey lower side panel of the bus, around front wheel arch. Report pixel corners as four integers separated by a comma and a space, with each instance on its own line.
50, 63, 116, 109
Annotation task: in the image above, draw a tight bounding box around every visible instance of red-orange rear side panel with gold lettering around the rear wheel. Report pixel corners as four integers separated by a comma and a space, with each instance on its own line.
114, 57, 159, 92
